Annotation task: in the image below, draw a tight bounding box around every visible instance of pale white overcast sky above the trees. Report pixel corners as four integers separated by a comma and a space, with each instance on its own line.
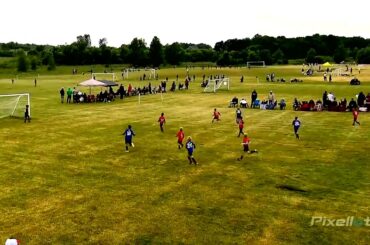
0, 0, 370, 47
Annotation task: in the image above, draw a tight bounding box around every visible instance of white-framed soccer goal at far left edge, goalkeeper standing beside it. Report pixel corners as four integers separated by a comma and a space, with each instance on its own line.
0, 93, 31, 118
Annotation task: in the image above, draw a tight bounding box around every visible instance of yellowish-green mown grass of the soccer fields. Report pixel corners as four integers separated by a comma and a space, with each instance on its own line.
0, 66, 370, 244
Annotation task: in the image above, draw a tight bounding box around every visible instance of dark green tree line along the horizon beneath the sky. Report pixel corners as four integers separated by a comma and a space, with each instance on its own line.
0, 34, 370, 71
